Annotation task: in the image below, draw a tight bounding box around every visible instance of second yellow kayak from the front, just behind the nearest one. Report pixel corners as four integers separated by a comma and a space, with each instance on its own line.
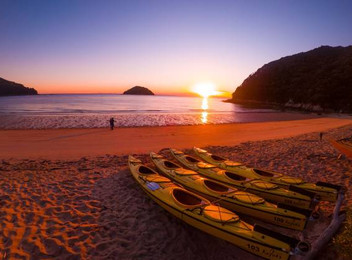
150, 150, 312, 231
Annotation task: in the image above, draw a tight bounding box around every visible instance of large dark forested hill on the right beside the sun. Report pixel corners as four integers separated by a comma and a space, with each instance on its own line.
232, 46, 352, 112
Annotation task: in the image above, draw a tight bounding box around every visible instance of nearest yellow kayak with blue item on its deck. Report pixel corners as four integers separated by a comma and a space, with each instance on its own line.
128, 156, 310, 260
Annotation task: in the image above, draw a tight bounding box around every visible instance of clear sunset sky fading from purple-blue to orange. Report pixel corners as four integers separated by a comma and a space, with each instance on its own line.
0, 0, 352, 94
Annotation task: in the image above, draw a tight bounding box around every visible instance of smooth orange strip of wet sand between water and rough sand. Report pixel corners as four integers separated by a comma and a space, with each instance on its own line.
0, 118, 352, 160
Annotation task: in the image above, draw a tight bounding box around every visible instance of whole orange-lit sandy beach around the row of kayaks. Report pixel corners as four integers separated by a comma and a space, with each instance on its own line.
0, 118, 352, 259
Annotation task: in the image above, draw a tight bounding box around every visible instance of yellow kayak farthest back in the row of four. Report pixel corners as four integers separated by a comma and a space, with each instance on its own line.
193, 147, 342, 201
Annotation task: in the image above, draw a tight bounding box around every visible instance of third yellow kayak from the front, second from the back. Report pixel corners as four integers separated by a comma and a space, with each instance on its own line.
168, 148, 317, 209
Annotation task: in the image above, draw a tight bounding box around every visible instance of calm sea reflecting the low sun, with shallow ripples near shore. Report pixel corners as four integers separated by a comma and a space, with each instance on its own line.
0, 94, 315, 129
